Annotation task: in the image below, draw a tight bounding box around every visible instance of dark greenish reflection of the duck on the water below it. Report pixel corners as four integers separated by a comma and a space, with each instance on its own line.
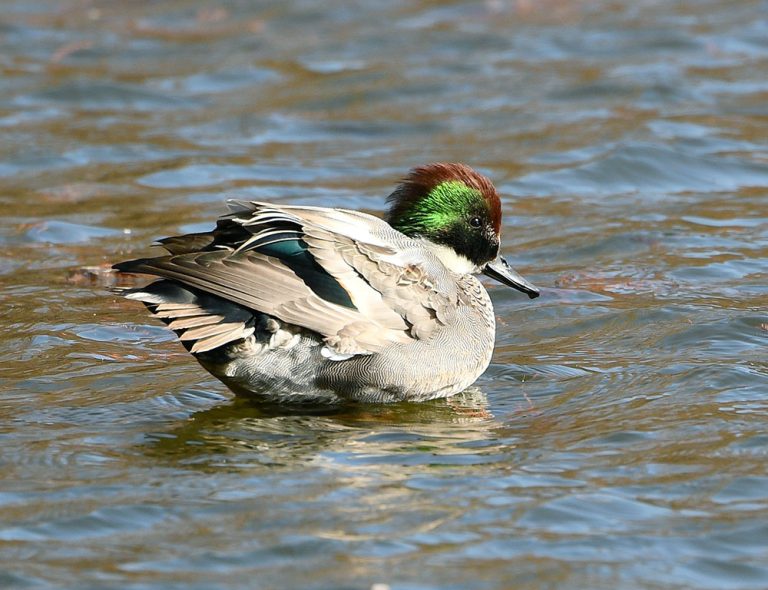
145, 389, 499, 468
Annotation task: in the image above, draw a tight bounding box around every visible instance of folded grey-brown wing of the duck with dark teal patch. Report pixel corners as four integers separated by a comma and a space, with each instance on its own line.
115, 201, 456, 358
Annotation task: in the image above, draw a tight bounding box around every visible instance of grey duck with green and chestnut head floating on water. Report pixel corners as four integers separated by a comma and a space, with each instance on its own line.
113, 163, 540, 403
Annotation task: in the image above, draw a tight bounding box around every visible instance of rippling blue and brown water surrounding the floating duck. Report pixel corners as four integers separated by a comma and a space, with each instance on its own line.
0, 0, 768, 590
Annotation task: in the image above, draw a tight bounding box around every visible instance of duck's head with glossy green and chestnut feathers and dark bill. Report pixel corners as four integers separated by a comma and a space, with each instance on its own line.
387, 163, 539, 299
